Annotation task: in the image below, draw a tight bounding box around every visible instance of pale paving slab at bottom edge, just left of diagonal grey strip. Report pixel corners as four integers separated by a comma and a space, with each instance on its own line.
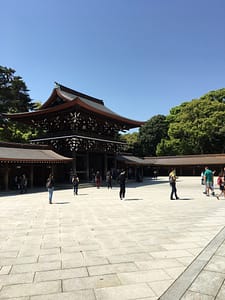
95, 283, 155, 300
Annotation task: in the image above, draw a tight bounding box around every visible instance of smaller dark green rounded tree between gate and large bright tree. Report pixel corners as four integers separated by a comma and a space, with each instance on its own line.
138, 115, 168, 156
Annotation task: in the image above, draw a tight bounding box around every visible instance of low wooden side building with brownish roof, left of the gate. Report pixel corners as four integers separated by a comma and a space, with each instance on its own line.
0, 142, 71, 190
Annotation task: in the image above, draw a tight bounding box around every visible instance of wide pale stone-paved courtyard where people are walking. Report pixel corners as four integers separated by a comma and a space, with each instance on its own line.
0, 177, 225, 300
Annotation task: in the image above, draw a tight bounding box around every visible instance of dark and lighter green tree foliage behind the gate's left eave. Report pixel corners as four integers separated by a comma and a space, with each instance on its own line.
0, 66, 38, 142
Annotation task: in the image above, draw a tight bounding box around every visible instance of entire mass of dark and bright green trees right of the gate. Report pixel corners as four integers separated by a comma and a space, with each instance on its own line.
123, 89, 225, 156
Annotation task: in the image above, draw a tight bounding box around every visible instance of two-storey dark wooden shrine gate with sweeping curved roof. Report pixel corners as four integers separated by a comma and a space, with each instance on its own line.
5, 84, 144, 180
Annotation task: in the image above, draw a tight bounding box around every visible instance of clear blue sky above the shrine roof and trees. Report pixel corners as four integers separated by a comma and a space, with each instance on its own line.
0, 0, 225, 121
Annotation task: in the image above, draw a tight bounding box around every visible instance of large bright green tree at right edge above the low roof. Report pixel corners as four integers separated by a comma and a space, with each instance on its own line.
156, 89, 225, 155
